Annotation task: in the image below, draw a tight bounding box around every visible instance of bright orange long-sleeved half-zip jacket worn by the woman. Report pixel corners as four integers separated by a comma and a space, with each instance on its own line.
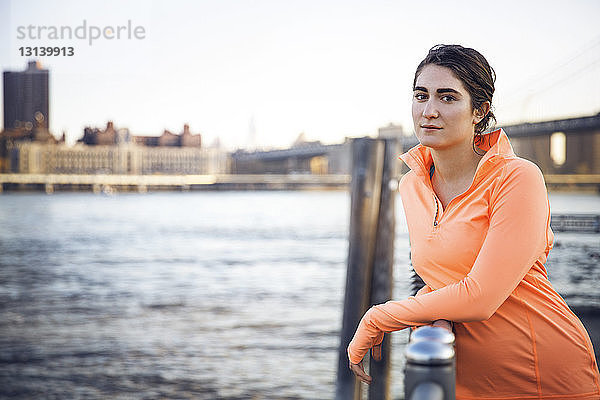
348, 130, 600, 400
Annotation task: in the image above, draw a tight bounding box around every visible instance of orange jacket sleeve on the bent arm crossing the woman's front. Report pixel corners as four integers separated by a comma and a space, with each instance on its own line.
348, 160, 550, 363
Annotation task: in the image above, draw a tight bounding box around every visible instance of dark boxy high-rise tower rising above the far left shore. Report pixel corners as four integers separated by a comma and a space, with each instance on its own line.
4, 61, 50, 129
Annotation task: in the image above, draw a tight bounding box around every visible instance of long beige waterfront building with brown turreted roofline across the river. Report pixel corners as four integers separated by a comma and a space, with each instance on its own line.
0, 117, 224, 175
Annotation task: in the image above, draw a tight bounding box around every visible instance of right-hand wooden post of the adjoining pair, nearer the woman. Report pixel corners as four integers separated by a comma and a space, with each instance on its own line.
369, 139, 400, 400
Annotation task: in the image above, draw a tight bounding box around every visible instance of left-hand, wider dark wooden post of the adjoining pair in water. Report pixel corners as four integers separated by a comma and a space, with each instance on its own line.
335, 138, 385, 400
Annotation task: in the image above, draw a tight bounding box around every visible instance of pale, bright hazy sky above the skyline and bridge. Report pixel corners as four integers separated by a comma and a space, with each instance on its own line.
0, 0, 600, 150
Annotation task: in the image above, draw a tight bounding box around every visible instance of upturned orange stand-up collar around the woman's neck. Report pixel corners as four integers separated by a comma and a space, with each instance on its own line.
399, 128, 515, 180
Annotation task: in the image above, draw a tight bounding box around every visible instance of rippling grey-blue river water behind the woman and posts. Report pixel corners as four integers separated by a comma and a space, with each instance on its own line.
0, 192, 600, 400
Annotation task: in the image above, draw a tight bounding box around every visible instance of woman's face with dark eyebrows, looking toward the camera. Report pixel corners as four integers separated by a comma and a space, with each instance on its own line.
412, 64, 481, 150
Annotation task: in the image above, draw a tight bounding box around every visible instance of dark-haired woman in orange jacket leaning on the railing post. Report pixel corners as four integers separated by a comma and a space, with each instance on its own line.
348, 45, 600, 400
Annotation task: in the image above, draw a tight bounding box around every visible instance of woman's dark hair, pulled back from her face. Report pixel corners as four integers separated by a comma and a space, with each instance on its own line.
413, 44, 496, 135
